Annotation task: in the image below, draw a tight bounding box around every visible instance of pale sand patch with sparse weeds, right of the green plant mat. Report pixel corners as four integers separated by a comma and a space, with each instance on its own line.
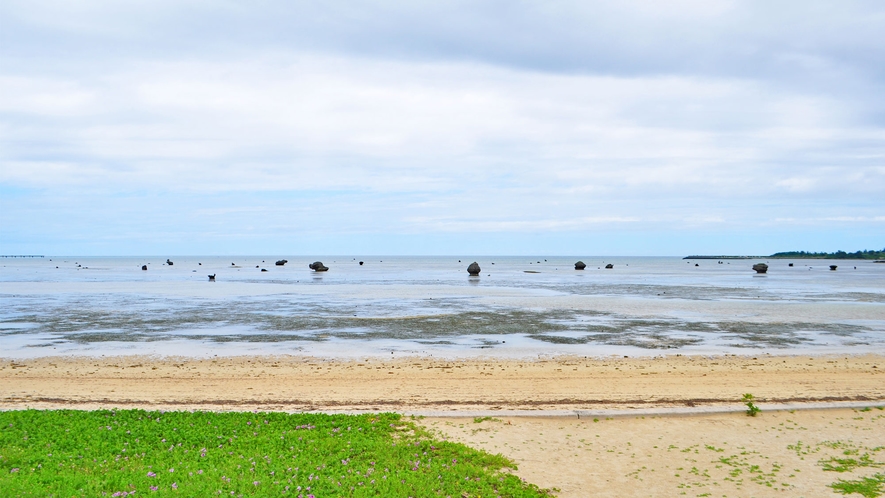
421, 405, 885, 498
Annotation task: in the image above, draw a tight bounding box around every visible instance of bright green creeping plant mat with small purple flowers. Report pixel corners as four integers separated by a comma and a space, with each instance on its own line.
0, 410, 550, 498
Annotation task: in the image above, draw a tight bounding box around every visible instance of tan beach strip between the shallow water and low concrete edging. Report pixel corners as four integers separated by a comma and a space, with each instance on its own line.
0, 355, 885, 412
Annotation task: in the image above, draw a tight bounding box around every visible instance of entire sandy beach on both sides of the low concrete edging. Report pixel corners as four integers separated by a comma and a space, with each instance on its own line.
0, 355, 885, 497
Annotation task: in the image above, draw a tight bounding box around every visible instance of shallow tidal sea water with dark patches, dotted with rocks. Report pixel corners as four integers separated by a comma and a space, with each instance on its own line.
0, 256, 885, 358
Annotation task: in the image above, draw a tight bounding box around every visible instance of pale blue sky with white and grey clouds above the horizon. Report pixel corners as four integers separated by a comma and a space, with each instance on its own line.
0, 0, 885, 256
